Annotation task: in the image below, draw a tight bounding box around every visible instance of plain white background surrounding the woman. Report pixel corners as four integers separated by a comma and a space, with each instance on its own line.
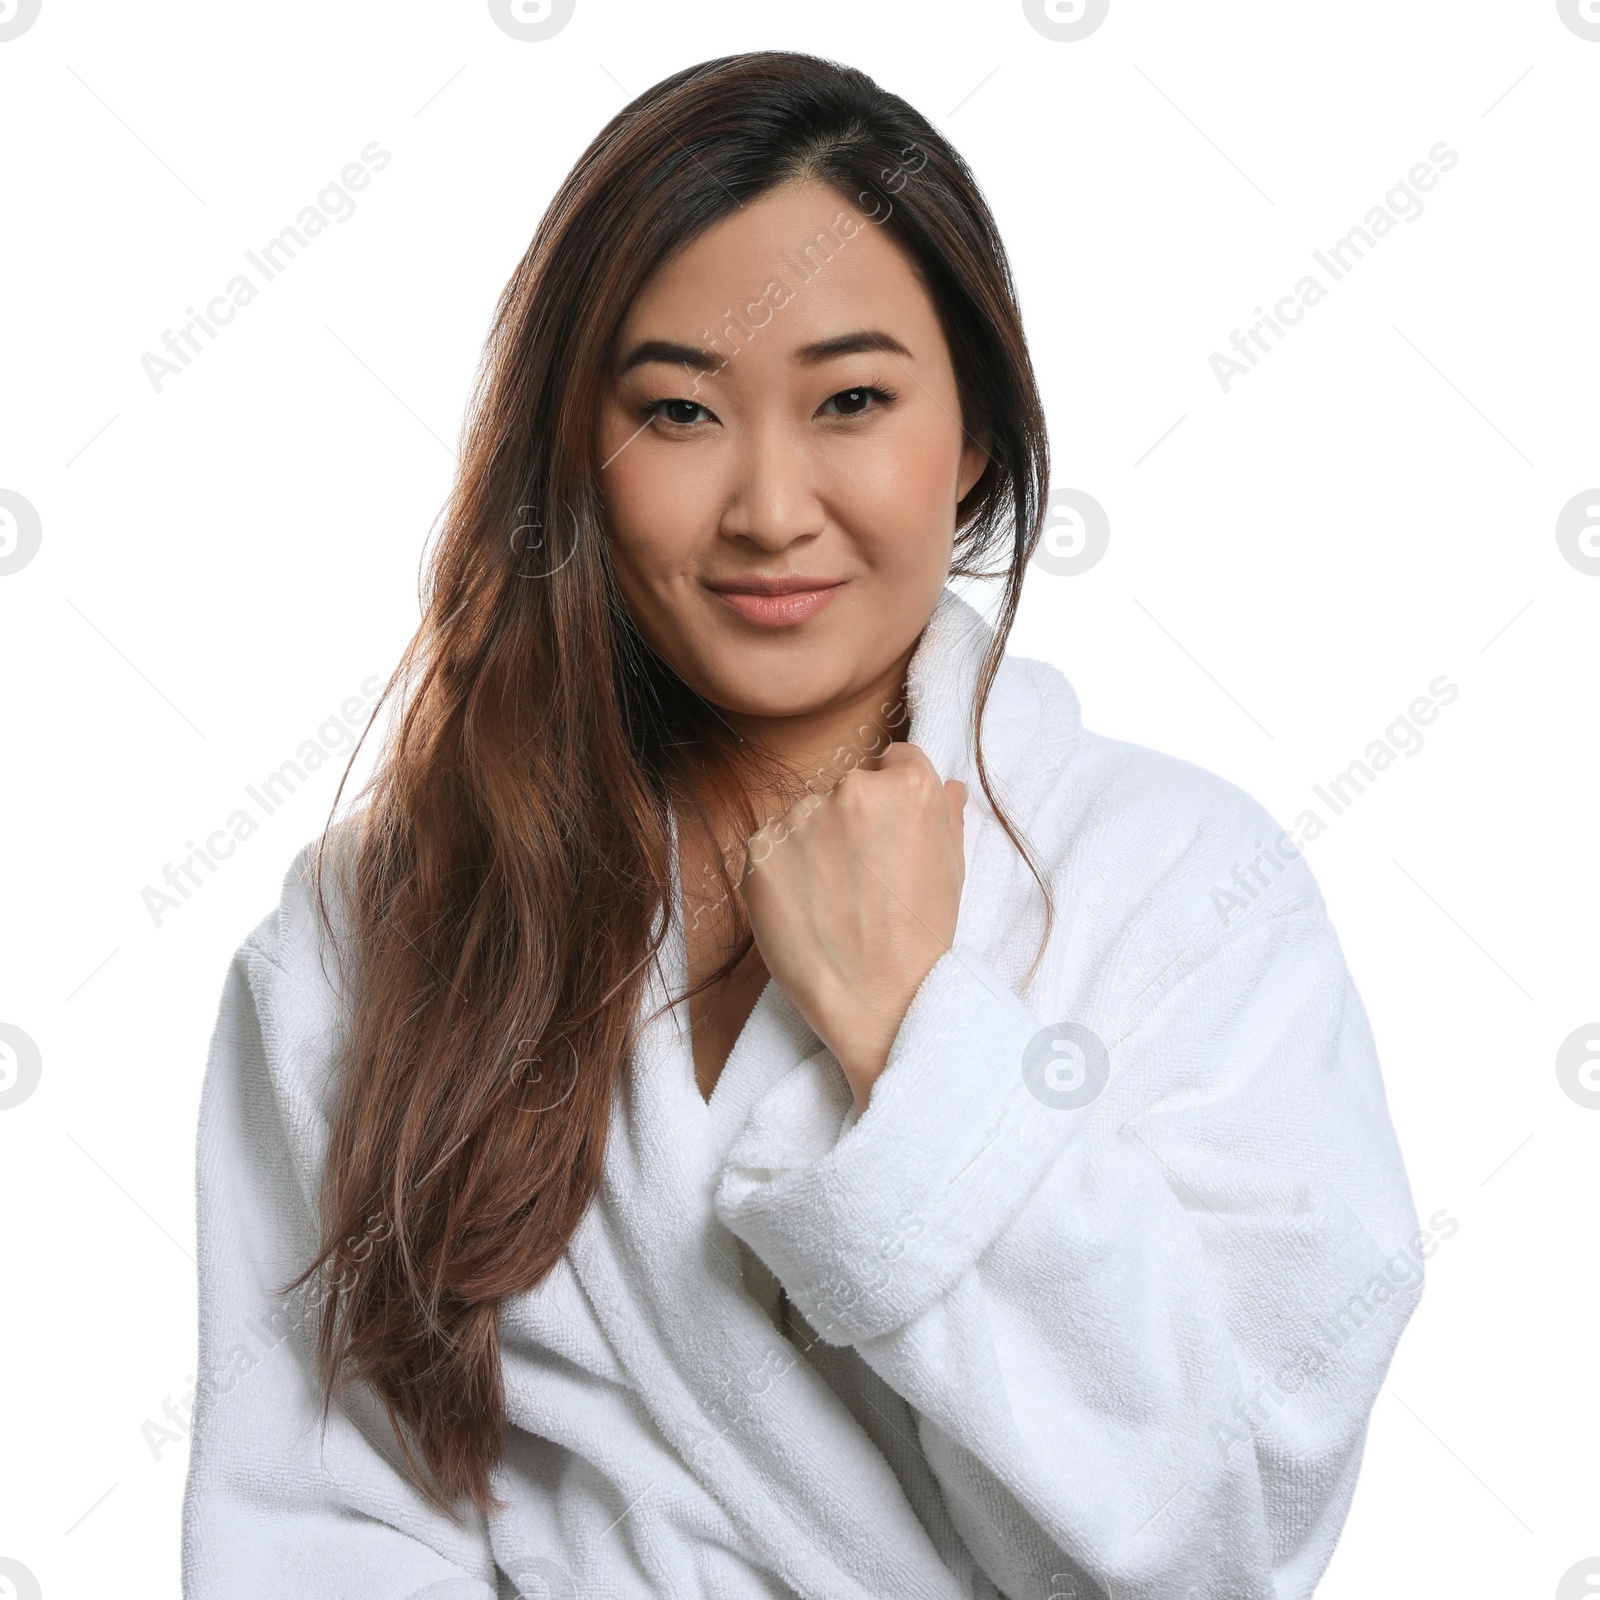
0, 0, 1600, 1600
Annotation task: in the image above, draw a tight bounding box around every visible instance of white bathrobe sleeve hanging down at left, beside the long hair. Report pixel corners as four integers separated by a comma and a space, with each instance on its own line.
182, 914, 496, 1600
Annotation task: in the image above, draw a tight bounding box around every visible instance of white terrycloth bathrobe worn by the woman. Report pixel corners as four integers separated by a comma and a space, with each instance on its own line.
184, 590, 1421, 1600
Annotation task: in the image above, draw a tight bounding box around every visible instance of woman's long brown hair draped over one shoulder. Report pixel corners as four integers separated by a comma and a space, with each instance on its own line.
286, 51, 1051, 1510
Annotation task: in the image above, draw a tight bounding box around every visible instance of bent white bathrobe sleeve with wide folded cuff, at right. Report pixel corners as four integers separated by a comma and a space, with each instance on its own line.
717, 896, 1422, 1600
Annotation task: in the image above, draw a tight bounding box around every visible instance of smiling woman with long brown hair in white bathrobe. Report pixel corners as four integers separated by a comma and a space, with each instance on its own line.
184, 53, 1421, 1600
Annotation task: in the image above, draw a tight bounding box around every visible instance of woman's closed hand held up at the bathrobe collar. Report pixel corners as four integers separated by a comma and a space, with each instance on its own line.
739, 742, 966, 1110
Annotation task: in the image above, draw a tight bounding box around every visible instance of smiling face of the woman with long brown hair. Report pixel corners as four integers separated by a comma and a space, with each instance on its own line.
597, 182, 987, 717
